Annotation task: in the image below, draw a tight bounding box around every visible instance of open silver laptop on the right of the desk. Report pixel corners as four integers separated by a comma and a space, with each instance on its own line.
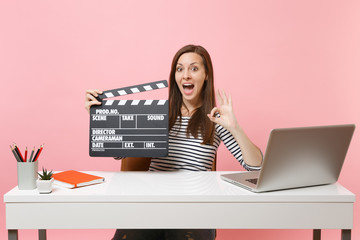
221, 124, 355, 192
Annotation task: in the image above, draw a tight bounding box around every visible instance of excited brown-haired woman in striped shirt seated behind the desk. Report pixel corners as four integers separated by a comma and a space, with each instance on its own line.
85, 45, 262, 240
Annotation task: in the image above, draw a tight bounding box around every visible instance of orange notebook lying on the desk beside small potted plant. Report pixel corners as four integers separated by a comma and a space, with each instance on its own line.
53, 170, 105, 188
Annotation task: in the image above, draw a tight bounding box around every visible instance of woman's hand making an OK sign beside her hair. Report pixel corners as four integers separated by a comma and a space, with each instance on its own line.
207, 90, 238, 132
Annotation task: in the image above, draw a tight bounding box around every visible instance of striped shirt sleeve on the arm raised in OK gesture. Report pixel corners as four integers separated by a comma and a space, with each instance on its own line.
215, 124, 261, 171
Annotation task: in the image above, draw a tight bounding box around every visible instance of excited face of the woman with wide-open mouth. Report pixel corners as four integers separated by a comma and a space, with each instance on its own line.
175, 52, 206, 107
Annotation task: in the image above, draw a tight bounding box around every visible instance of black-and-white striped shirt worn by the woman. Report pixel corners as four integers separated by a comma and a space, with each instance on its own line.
149, 117, 260, 171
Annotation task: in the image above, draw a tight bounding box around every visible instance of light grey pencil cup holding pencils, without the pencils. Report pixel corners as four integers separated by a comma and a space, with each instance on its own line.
17, 161, 38, 190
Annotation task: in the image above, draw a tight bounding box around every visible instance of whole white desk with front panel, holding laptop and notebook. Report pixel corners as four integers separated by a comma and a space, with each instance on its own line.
4, 172, 355, 240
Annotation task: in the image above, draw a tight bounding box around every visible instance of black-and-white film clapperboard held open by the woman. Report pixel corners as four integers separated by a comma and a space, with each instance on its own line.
90, 80, 169, 157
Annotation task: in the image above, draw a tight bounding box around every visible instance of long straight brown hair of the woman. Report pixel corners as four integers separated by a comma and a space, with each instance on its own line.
169, 45, 215, 144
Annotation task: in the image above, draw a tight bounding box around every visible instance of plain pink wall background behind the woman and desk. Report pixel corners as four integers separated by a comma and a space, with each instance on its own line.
0, 0, 360, 240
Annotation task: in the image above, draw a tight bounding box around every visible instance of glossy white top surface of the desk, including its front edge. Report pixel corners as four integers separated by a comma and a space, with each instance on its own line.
4, 171, 355, 203
